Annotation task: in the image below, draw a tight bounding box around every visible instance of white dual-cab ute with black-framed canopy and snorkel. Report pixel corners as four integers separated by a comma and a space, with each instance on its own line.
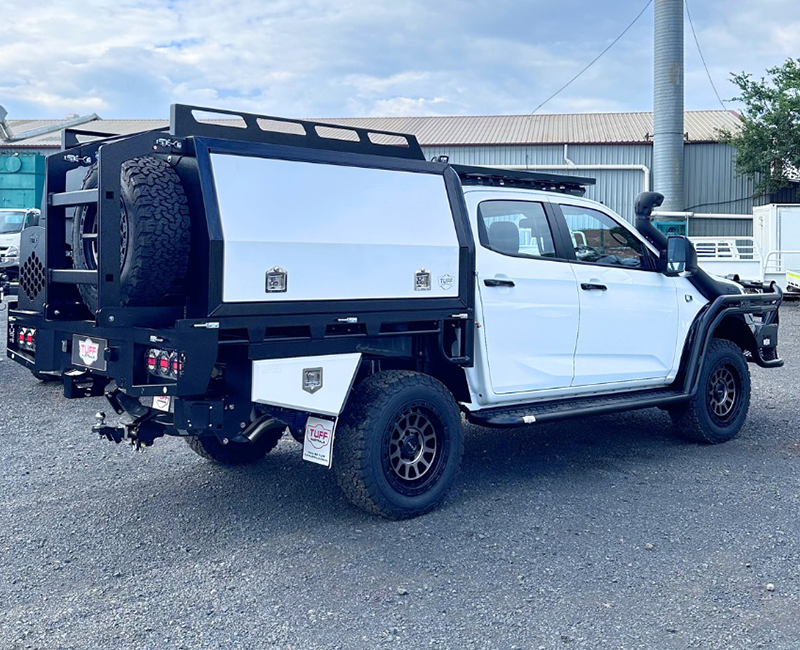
8, 105, 783, 519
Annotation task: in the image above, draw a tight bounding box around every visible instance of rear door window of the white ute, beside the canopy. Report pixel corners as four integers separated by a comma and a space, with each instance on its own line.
478, 201, 556, 257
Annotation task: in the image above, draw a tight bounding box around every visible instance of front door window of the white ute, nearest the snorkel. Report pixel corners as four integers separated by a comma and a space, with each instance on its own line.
561, 205, 646, 269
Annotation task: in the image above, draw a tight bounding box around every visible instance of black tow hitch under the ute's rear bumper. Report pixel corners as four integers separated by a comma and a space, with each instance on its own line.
92, 388, 175, 451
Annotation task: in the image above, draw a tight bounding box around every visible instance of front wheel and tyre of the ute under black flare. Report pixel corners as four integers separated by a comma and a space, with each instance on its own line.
670, 339, 750, 444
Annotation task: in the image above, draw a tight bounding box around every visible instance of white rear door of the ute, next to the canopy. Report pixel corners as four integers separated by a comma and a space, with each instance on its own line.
477, 200, 578, 394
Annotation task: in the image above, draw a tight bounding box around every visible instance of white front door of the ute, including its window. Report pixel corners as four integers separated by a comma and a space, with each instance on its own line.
560, 203, 678, 387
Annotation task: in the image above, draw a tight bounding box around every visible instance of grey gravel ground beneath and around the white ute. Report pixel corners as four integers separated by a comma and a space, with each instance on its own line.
0, 304, 800, 650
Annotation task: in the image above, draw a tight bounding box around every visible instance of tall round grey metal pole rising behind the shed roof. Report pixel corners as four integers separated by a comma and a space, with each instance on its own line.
653, 0, 686, 212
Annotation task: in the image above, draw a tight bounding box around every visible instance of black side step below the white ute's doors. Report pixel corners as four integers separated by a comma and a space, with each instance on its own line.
467, 388, 689, 428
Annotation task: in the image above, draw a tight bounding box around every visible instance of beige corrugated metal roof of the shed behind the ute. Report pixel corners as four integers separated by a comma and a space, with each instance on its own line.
0, 111, 741, 148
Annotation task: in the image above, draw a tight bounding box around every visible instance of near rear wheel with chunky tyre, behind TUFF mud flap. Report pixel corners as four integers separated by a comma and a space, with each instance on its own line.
333, 370, 464, 519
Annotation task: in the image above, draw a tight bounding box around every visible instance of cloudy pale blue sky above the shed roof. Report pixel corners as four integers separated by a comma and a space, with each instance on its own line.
0, 0, 800, 119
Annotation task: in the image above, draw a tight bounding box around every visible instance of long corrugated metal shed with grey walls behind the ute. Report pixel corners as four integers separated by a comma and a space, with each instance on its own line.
0, 111, 768, 235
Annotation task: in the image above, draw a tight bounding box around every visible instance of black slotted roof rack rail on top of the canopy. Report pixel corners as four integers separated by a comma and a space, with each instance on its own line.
170, 104, 425, 160
